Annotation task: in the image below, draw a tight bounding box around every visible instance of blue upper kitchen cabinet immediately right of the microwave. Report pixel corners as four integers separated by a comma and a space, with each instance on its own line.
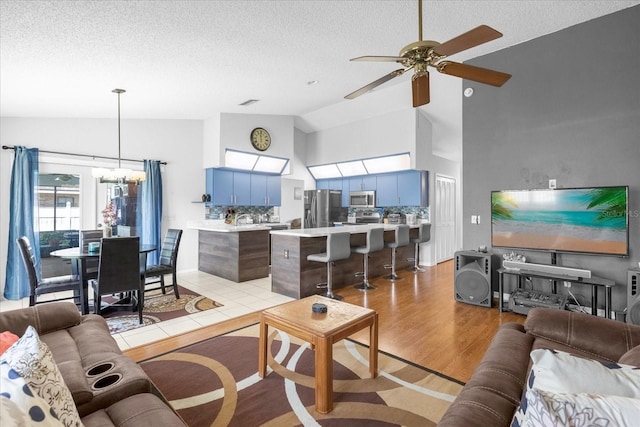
376, 170, 429, 207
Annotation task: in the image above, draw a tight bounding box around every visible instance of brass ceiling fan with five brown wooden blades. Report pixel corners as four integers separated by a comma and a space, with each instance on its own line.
345, 0, 511, 107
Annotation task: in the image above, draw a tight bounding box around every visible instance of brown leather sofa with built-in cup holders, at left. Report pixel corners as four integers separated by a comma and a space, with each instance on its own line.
0, 302, 184, 427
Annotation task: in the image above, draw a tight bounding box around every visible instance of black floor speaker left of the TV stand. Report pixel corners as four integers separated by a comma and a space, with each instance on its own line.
454, 251, 493, 307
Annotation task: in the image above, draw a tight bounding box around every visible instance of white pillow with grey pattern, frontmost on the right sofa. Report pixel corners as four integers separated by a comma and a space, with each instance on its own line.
520, 389, 640, 427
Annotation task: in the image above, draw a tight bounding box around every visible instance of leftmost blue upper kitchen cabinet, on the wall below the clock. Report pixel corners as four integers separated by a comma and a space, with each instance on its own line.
207, 168, 251, 206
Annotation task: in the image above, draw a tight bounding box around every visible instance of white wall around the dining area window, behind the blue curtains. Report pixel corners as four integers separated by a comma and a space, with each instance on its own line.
0, 118, 205, 298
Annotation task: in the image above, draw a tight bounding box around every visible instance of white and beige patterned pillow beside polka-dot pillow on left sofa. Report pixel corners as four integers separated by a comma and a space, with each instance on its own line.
0, 326, 82, 427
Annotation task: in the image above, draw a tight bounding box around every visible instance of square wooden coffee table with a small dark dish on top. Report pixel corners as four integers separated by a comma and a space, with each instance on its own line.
258, 295, 378, 414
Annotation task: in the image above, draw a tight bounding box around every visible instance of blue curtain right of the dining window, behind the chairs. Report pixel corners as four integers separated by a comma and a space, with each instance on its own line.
136, 160, 162, 265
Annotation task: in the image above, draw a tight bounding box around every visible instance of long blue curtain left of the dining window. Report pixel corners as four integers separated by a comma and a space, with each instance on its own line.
4, 146, 40, 300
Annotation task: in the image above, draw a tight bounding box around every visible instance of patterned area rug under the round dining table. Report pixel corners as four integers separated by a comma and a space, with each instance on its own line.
103, 286, 222, 335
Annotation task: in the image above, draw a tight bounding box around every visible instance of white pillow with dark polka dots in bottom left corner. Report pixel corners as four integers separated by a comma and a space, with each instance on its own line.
0, 362, 62, 427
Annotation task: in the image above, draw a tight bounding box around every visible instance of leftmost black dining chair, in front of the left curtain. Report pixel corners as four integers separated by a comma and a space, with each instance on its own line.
17, 236, 82, 308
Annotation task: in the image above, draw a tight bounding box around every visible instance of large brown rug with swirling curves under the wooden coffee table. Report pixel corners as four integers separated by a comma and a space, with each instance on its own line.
140, 324, 462, 427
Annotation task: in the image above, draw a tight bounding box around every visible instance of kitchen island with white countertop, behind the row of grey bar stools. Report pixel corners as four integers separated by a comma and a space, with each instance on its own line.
271, 224, 418, 299
